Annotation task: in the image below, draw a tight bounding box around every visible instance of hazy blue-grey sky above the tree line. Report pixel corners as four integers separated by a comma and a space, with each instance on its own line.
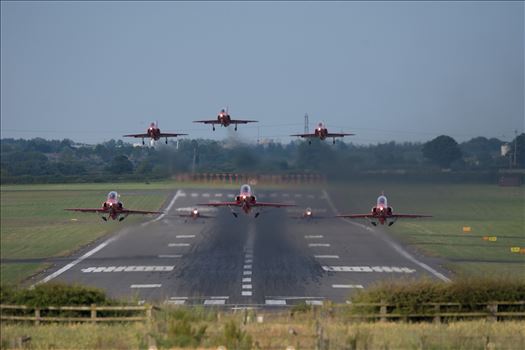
1, 1, 525, 144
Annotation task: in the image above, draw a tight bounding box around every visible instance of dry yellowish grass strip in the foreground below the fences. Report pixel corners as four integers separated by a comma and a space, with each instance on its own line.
0, 314, 525, 349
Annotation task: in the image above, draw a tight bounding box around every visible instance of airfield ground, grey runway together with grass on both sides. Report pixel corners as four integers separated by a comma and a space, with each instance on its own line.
1, 183, 525, 306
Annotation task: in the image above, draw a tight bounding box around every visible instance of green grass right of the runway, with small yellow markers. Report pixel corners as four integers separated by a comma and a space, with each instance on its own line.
329, 182, 525, 278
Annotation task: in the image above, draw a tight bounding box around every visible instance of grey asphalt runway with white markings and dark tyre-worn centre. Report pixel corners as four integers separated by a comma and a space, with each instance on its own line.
34, 189, 447, 307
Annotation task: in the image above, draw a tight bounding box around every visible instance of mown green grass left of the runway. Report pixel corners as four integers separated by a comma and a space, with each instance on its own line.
0, 184, 169, 284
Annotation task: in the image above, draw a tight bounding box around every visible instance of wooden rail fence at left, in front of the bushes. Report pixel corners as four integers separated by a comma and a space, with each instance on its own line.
0, 305, 153, 325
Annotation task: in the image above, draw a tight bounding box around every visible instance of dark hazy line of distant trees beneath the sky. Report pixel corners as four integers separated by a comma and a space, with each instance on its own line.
0, 134, 525, 184
